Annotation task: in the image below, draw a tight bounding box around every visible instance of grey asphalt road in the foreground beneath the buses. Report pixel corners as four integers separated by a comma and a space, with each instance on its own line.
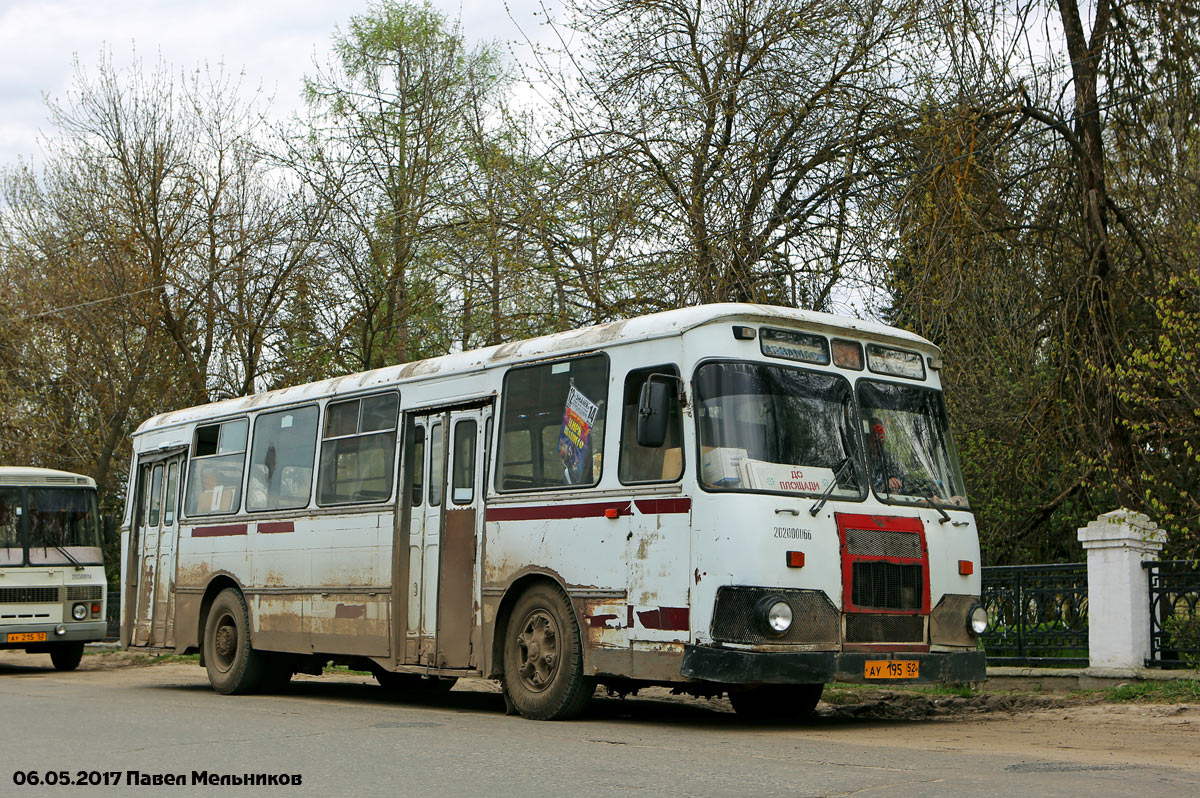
0, 658, 1200, 798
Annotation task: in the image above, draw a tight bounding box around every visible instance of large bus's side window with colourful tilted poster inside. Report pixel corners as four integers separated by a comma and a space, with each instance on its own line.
496, 354, 608, 491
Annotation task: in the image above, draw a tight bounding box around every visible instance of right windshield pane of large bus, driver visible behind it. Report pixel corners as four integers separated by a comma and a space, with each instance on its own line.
858, 379, 967, 506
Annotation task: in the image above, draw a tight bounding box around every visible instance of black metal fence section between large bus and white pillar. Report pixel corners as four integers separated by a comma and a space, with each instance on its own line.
980, 563, 1087, 666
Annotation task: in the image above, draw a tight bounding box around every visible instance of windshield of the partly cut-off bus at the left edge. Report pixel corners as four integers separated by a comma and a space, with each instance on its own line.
0, 487, 101, 564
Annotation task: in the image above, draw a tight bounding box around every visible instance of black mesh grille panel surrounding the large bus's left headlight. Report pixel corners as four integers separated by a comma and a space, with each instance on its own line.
710, 587, 841, 647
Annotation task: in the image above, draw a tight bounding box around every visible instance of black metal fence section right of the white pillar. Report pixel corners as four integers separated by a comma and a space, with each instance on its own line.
1141, 559, 1200, 668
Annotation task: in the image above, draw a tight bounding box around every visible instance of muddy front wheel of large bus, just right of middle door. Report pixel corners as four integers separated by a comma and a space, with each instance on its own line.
504, 583, 595, 720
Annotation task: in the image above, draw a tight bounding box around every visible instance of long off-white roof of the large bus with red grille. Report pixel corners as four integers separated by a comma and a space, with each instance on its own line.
133, 302, 937, 437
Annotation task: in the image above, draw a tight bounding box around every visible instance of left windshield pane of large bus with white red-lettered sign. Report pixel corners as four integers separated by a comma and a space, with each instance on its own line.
696, 362, 865, 498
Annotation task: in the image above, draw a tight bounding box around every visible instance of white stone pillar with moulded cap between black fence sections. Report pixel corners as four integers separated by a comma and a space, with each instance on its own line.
1079, 509, 1165, 678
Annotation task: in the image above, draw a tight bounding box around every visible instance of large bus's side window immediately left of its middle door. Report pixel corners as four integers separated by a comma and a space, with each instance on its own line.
317, 391, 400, 506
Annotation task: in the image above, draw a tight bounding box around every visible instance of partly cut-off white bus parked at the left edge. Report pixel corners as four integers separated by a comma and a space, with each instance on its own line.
0, 466, 108, 671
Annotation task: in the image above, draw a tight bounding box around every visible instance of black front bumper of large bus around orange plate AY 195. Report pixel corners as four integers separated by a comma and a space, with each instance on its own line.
679, 646, 988, 684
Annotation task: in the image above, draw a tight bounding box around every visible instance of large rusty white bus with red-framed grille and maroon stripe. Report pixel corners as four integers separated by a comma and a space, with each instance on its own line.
122, 305, 985, 719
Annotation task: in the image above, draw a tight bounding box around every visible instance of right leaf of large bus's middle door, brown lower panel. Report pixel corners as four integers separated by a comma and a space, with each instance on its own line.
433, 408, 491, 667
